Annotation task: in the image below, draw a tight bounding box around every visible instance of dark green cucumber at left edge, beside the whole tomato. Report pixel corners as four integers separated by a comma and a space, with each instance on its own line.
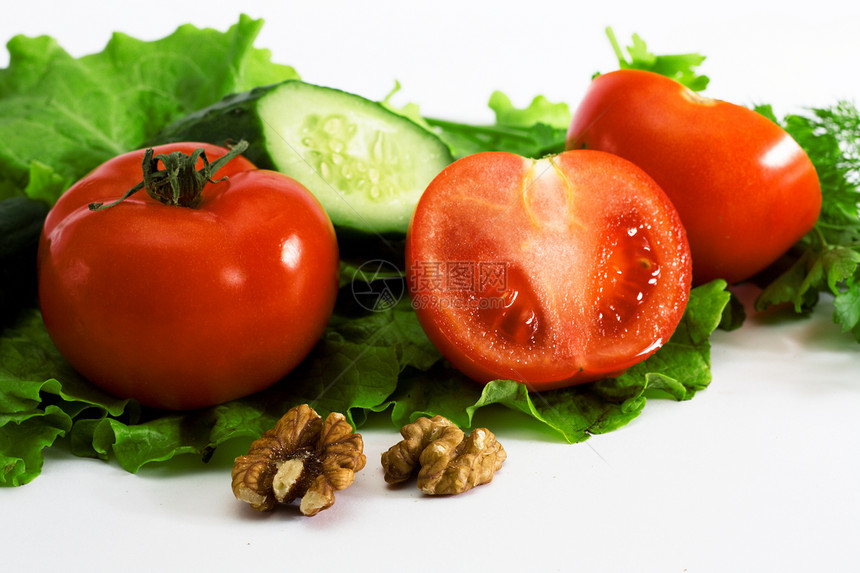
0, 197, 48, 330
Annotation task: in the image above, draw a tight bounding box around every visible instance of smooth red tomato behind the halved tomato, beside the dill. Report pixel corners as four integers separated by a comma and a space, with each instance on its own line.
566, 70, 821, 284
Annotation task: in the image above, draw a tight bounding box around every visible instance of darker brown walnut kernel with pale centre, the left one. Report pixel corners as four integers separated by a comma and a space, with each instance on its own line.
232, 404, 366, 515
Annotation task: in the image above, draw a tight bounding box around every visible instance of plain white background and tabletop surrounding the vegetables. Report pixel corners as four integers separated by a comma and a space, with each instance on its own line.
0, 0, 860, 572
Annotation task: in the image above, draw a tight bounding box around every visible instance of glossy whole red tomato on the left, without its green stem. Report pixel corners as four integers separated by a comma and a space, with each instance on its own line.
39, 143, 339, 409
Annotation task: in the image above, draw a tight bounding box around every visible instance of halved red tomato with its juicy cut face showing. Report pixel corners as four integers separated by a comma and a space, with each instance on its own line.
406, 147, 690, 390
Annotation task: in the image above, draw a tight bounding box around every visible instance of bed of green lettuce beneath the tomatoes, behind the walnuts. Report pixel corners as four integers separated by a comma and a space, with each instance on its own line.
0, 282, 729, 485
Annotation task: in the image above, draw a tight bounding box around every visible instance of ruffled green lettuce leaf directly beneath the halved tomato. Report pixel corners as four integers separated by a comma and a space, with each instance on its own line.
375, 281, 731, 442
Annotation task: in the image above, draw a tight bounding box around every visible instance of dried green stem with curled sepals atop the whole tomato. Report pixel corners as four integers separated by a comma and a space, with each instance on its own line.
89, 140, 248, 211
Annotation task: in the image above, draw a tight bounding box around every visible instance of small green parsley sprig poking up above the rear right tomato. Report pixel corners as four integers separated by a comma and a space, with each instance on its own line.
606, 28, 710, 91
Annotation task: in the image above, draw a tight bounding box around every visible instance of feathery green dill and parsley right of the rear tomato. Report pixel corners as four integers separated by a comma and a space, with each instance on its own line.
755, 102, 860, 342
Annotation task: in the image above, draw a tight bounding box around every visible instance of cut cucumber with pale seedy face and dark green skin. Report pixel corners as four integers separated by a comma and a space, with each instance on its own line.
154, 80, 453, 236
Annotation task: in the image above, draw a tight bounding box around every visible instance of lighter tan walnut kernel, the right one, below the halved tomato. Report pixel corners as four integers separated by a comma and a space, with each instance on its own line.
382, 416, 507, 495
